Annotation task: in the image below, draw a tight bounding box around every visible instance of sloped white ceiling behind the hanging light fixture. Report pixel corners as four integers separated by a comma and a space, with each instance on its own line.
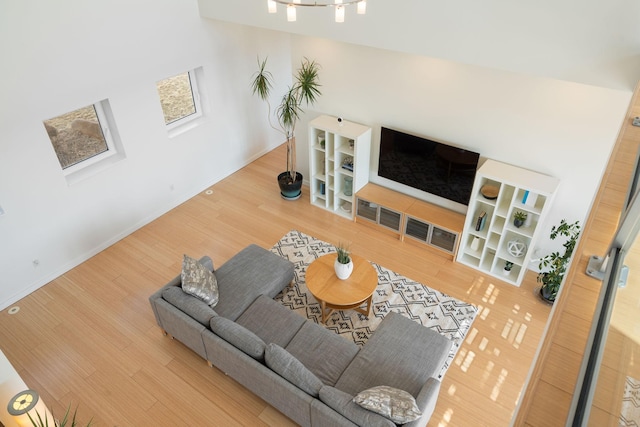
198, 0, 640, 91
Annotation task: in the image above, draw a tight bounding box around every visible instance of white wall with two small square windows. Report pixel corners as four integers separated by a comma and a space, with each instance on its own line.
0, 0, 291, 308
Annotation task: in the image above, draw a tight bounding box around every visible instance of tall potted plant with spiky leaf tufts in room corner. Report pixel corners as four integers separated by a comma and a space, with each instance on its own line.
251, 58, 321, 200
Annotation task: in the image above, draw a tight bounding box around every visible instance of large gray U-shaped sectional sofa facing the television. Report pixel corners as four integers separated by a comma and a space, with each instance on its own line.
149, 245, 452, 427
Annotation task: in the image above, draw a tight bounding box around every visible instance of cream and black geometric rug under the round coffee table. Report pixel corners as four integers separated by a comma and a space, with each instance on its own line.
271, 230, 478, 376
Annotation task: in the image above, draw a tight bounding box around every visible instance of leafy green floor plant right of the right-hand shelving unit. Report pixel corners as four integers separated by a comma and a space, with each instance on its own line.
538, 219, 580, 303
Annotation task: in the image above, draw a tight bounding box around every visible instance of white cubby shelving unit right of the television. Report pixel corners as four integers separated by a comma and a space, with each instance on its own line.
457, 160, 559, 286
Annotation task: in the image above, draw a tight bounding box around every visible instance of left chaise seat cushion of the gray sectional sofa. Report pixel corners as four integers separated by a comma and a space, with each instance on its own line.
215, 245, 293, 320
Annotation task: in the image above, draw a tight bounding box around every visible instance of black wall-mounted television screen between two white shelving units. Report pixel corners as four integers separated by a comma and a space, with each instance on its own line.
378, 127, 480, 205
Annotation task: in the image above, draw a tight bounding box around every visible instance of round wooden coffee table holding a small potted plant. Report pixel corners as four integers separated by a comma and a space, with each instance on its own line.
305, 254, 378, 323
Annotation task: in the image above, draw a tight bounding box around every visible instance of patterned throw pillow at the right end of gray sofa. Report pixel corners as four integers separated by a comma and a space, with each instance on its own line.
353, 385, 422, 424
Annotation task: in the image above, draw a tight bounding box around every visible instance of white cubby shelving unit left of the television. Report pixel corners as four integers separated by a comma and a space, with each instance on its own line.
309, 116, 371, 218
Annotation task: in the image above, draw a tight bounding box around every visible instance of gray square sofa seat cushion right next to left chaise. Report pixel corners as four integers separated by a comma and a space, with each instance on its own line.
236, 295, 306, 348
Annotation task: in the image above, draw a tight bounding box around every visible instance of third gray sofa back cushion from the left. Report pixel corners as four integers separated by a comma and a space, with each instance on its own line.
264, 343, 323, 397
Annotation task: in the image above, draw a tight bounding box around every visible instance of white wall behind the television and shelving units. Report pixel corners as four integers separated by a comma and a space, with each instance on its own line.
293, 36, 631, 260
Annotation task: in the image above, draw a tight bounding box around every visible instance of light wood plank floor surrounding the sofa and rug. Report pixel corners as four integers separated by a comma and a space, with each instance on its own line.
0, 147, 550, 427
